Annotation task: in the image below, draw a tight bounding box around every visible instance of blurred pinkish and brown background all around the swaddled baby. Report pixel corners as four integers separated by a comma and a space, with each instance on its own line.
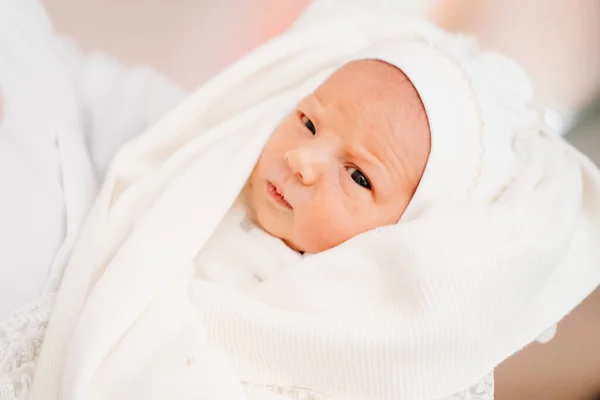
44, 0, 600, 400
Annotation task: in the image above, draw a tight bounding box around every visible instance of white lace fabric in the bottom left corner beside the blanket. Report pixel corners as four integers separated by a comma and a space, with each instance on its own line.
0, 295, 54, 400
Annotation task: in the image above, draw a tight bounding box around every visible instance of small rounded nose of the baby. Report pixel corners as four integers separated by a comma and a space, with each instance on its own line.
285, 148, 331, 186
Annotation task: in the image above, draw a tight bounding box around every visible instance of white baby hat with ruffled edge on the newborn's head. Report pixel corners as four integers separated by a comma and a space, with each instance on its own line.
353, 35, 532, 221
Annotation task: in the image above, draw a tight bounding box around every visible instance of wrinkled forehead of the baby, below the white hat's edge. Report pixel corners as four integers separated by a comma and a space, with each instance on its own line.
301, 59, 430, 192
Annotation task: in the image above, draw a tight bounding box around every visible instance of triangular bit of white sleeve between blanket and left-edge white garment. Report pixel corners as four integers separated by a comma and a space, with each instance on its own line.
56, 37, 186, 181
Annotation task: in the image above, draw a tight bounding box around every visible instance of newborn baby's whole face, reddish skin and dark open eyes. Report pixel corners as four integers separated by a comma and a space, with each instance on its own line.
247, 60, 430, 253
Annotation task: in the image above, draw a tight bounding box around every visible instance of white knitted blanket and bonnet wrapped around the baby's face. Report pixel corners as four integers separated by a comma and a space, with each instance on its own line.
31, 4, 600, 399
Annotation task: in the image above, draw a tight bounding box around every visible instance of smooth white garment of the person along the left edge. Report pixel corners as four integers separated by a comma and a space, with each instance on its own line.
0, 0, 96, 316
